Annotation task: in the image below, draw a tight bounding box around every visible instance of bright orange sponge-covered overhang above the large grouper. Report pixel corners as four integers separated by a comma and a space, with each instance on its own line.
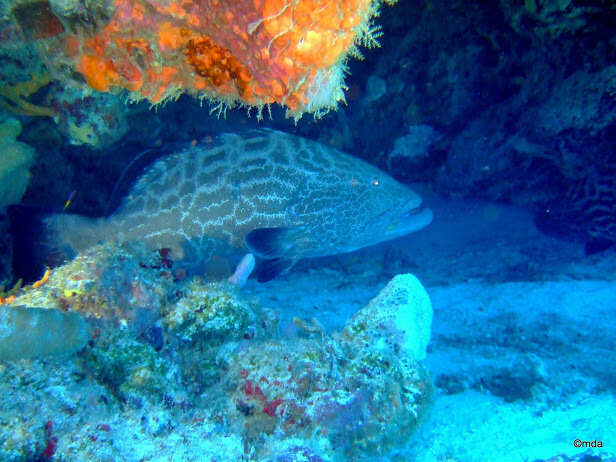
66, 0, 395, 118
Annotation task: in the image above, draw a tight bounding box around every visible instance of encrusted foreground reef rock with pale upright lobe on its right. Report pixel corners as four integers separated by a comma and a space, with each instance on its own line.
217, 274, 432, 460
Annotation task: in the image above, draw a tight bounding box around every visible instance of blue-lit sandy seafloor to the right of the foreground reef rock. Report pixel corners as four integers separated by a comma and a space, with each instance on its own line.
246, 189, 616, 462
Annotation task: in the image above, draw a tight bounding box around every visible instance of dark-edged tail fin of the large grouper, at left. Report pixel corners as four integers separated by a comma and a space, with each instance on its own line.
8, 205, 101, 283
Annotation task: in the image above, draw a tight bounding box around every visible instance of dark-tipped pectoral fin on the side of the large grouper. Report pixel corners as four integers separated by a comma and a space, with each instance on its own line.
244, 227, 306, 259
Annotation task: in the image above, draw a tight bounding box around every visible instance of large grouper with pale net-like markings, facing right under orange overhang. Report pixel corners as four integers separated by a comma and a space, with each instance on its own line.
47, 130, 432, 280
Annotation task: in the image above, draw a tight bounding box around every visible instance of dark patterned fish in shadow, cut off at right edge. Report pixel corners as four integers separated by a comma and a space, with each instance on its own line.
535, 159, 616, 255
